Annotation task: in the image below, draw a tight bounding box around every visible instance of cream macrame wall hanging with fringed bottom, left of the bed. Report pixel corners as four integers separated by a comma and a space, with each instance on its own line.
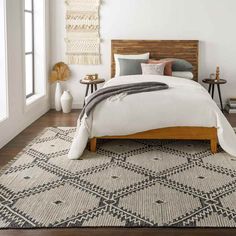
65, 0, 101, 65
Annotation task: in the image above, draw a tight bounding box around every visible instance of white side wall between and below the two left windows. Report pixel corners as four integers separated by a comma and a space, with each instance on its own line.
0, 0, 49, 148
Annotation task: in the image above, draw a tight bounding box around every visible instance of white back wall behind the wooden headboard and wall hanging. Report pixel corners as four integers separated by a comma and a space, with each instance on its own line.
50, 0, 236, 107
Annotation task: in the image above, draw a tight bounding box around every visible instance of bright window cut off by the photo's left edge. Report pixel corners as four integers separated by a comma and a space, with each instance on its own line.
0, 0, 8, 121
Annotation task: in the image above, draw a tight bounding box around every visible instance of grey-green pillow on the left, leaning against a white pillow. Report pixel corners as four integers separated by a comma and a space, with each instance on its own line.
118, 59, 148, 76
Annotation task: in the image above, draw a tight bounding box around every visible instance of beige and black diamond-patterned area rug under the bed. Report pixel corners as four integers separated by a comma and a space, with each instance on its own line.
0, 128, 236, 229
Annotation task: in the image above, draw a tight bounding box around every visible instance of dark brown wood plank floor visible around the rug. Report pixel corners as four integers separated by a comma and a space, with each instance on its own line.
0, 110, 236, 236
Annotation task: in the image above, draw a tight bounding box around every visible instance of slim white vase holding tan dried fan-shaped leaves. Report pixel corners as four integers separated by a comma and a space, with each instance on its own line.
49, 62, 71, 111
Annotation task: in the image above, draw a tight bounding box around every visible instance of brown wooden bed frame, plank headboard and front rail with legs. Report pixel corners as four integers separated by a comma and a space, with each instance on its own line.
90, 40, 218, 154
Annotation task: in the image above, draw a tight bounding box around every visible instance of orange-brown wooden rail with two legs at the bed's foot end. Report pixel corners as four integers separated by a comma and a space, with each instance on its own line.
90, 127, 218, 154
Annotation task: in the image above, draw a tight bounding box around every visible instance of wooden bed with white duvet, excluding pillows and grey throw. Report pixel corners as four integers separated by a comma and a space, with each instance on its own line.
69, 40, 236, 159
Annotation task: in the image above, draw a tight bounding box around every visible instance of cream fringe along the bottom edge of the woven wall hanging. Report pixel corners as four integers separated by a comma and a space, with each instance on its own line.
67, 55, 101, 65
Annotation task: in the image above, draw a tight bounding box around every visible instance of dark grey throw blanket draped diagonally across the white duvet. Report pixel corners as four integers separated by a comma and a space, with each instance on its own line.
80, 82, 169, 121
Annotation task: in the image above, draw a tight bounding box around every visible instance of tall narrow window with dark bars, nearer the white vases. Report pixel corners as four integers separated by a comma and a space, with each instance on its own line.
24, 0, 35, 98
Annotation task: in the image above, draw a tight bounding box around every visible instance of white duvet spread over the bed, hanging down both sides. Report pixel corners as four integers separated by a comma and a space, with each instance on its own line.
69, 75, 236, 159
